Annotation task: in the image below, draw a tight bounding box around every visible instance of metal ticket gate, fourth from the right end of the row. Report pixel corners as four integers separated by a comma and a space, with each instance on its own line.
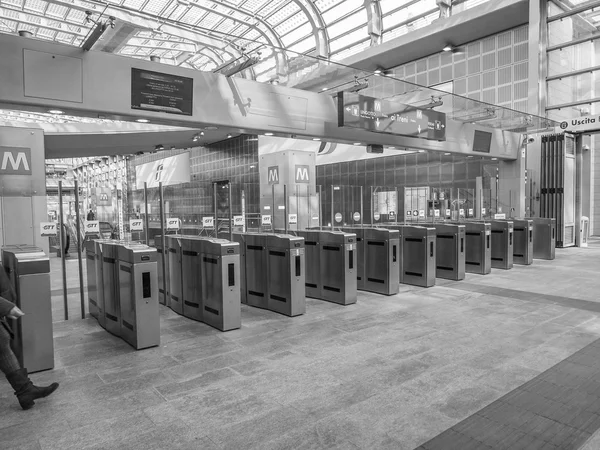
462, 222, 492, 275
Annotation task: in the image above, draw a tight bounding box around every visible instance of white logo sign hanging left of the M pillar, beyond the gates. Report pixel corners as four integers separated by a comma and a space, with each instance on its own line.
135, 152, 191, 189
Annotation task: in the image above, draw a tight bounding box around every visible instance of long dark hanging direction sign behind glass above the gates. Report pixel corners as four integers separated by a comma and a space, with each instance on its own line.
338, 92, 446, 141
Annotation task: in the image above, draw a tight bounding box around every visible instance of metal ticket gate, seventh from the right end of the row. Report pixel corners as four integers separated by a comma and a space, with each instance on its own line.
364, 228, 400, 295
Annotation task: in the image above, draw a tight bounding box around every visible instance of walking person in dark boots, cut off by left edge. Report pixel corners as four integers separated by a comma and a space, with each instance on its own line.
0, 266, 58, 409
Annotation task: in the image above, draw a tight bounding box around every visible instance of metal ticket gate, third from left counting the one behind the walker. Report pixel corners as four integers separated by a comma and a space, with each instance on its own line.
163, 235, 242, 331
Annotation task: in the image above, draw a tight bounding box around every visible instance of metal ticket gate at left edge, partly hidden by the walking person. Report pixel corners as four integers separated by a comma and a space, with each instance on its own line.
0, 245, 54, 372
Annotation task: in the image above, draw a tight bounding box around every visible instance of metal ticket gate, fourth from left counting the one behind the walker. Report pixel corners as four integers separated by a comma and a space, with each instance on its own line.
233, 233, 306, 317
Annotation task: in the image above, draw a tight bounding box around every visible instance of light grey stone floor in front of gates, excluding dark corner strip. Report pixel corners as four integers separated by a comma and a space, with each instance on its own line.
0, 246, 600, 450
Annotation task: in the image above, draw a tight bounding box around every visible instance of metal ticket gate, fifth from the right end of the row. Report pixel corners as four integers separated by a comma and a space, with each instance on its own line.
434, 223, 466, 281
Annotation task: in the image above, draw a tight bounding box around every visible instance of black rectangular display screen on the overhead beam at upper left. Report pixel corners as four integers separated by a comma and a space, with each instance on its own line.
131, 69, 194, 116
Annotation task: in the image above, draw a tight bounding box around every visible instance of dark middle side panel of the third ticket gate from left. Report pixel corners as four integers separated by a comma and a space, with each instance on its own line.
181, 236, 203, 321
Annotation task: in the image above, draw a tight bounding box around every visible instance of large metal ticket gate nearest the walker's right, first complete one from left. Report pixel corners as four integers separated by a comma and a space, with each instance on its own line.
85, 239, 160, 350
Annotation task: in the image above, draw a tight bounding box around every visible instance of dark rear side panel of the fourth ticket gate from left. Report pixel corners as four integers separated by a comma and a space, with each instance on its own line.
244, 233, 270, 309
